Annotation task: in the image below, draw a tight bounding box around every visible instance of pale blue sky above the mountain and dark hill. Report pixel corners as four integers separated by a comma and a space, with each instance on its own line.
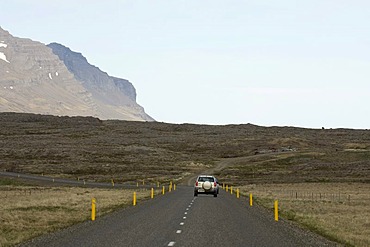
0, 0, 370, 128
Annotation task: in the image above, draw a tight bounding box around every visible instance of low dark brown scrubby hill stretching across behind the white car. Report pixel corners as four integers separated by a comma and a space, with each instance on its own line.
0, 113, 370, 185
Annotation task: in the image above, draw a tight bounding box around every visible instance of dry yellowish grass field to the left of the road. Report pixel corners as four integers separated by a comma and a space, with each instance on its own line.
0, 180, 159, 247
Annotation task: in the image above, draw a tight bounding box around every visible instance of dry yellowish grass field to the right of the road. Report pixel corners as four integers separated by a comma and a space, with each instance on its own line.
240, 183, 370, 247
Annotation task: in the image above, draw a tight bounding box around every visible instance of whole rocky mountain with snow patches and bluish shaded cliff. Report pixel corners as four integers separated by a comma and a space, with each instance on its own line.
0, 27, 154, 121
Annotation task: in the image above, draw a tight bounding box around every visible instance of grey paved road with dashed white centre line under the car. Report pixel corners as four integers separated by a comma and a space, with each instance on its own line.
21, 186, 336, 247
